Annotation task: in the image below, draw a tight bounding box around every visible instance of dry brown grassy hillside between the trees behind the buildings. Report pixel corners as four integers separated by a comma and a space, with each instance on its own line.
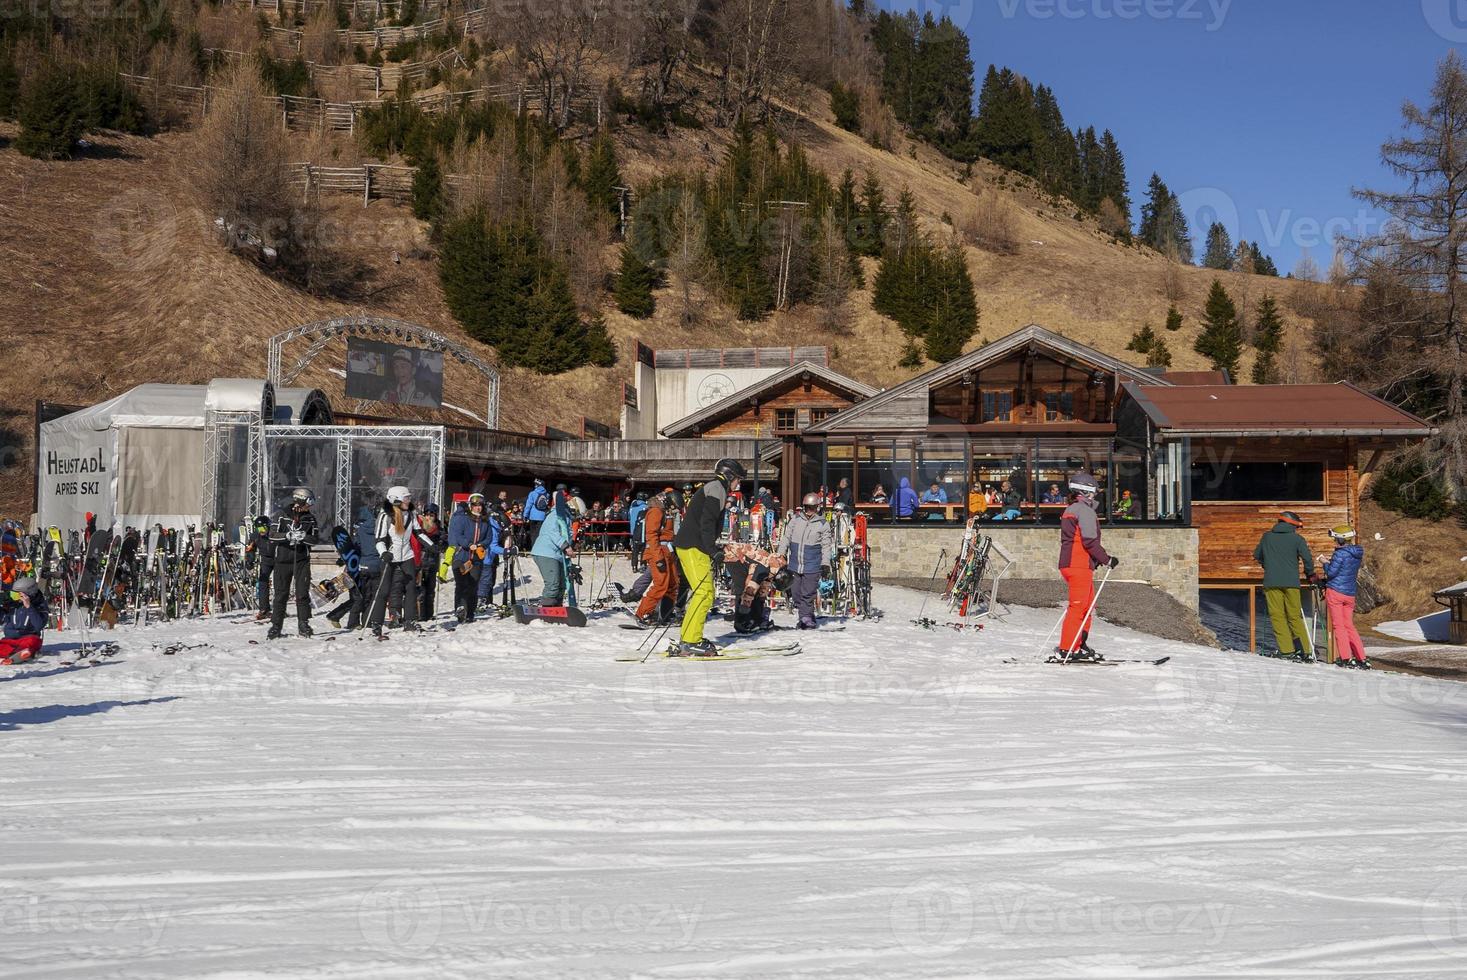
0, 86, 1467, 613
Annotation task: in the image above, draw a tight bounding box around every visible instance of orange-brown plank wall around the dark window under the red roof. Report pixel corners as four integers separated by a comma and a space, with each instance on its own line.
1191, 437, 1360, 585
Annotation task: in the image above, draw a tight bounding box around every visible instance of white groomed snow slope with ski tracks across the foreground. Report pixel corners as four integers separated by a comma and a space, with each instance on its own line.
0, 588, 1467, 980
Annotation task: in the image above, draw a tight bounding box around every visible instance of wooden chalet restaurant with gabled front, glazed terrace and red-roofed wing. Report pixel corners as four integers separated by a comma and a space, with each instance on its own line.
786, 326, 1432, 627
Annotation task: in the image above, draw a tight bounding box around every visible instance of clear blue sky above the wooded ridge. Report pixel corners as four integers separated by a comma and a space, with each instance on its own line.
883, 0, 1467, 273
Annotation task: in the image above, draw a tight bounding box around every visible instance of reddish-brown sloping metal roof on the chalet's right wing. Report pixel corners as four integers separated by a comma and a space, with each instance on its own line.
1125, 381, 1433, 436
